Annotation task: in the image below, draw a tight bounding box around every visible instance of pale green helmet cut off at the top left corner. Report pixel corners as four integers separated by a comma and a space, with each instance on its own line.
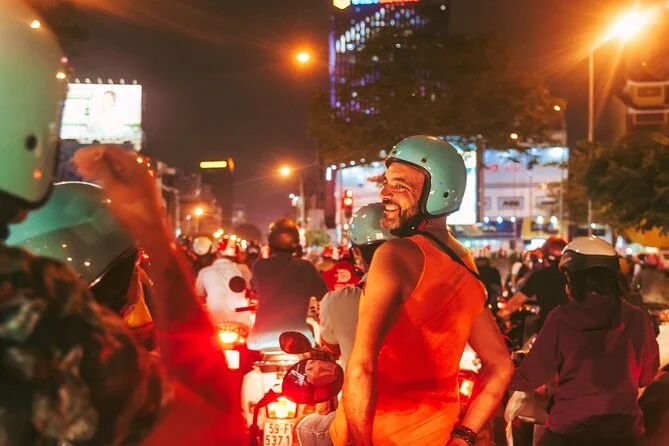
0, 0, 67, 208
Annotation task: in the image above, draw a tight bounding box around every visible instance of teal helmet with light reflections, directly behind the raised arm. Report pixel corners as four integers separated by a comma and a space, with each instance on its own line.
6, 181, 136, 286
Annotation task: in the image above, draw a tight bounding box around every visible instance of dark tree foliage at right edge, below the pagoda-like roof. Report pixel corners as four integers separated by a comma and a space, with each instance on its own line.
581, 133, 669, 233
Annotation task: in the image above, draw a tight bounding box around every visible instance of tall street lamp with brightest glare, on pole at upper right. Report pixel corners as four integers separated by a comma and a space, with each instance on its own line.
588, 6, 653, 235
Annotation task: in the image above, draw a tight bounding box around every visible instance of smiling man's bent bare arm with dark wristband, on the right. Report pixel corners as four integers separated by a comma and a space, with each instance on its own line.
462, 309, 513, 432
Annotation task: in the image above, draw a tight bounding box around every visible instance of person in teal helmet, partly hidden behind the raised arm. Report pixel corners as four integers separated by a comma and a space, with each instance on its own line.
6, 182, 155, 349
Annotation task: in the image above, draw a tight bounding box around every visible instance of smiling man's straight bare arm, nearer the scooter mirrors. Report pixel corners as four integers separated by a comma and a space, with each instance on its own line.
342, 239, 422, 446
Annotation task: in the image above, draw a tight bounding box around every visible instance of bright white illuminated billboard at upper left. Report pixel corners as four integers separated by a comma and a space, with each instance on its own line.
60, 83, 142, 150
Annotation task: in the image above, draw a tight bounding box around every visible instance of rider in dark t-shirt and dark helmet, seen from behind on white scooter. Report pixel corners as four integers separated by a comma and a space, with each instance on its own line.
248, 217, 327, 350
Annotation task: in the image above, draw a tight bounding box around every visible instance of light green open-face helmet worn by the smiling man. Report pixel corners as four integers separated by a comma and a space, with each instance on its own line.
386, 135, 467, 217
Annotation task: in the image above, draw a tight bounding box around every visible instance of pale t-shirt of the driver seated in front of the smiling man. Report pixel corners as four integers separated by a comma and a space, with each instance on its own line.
321, 276, 367, 370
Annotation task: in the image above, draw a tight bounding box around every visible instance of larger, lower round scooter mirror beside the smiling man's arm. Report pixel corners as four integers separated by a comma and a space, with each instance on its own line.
281, 359, 344, 404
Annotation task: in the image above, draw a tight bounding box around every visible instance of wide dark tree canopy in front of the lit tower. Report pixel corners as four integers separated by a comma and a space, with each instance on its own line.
309, 28, 562, 161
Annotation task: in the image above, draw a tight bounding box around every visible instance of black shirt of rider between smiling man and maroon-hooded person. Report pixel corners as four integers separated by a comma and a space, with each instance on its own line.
520, 263, 569, 325
